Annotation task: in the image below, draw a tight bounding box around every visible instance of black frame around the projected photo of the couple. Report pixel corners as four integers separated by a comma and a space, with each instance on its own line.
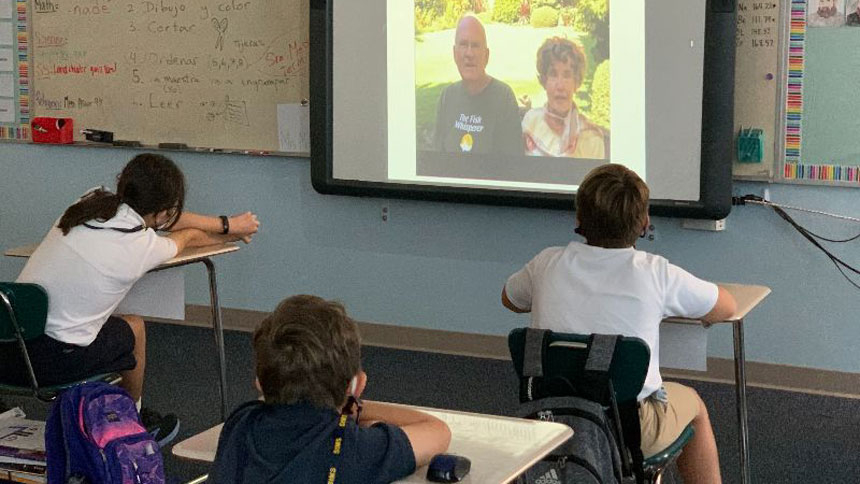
309, 0, 736, 220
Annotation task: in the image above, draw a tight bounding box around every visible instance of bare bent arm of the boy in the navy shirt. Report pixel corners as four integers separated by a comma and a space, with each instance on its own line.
361, 400, 451, 467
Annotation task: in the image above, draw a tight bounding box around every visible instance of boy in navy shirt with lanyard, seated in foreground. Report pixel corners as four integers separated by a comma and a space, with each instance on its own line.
209, 296, 451, 484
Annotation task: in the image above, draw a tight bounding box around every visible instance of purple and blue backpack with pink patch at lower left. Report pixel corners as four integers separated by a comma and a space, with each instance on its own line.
45, 382, 164, 484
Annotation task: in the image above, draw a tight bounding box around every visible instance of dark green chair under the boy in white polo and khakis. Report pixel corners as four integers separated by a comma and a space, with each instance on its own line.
508, 328, 694, 484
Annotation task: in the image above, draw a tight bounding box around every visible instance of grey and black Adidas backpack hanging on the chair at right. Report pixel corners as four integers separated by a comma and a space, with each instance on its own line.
516, 329, 643, 484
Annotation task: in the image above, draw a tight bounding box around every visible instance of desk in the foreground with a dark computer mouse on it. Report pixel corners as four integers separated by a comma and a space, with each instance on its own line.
173, 406, 573, 484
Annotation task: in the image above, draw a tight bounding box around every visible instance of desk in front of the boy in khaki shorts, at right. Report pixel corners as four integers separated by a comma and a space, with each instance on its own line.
665, 283, 770, 484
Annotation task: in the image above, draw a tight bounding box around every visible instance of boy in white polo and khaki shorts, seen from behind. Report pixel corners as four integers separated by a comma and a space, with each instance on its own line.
502, 165, 736, 483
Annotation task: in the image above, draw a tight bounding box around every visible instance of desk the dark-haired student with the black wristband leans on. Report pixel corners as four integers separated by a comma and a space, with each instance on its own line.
5, 242, 239, 420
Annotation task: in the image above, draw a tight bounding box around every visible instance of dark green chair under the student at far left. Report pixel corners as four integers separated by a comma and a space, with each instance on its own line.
0, 282, 122, 402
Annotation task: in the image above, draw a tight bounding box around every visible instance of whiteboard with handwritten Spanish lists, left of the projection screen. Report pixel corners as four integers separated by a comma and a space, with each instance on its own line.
25, 0, 310, 154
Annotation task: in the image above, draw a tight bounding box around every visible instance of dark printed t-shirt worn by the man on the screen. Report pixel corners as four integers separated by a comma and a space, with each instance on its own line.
433, 79, 525, 155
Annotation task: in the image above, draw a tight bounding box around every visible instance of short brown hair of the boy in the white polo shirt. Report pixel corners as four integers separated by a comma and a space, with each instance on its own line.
576, 164, 650, 248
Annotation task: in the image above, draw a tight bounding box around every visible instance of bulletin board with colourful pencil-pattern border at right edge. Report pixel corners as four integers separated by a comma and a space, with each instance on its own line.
778, 0, 860, 187
